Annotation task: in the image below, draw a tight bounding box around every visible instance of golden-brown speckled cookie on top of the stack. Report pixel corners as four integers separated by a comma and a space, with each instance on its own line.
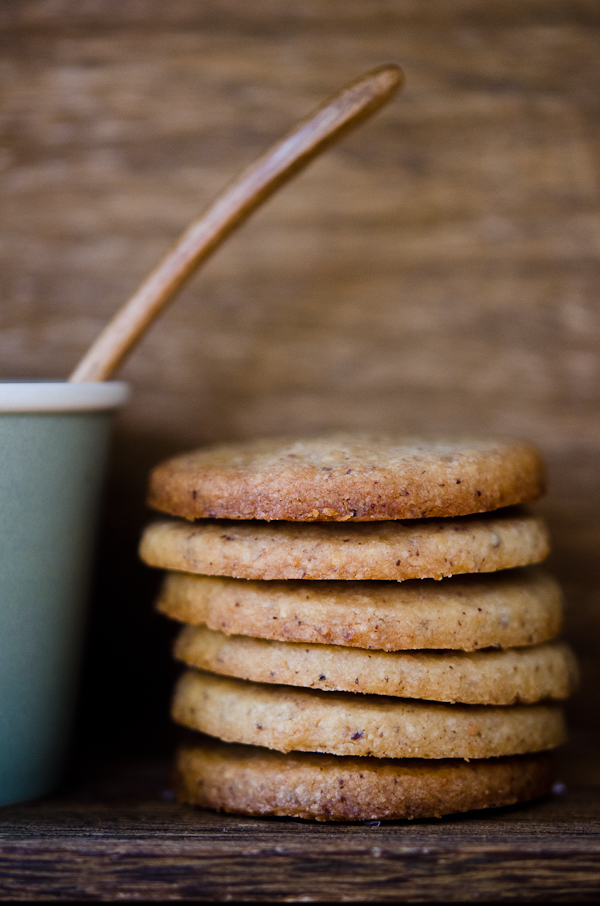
148, 434, 545, 522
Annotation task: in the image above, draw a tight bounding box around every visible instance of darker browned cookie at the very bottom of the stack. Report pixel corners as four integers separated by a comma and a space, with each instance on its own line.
175, 737, 553, 821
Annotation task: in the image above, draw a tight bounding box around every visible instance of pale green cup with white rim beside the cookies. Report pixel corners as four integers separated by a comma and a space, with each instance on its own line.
0, 382, 128, 805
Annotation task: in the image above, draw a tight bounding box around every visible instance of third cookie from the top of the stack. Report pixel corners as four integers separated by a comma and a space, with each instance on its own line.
156, 567, 562, 651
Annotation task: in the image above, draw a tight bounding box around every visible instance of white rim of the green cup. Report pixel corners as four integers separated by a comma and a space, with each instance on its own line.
0, 380, 130, 414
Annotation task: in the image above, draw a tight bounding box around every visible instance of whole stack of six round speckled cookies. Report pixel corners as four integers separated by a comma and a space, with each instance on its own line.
141, 435, 576, 821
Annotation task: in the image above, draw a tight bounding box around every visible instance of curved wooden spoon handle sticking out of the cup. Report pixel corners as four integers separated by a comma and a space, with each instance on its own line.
69, 66, 404, 381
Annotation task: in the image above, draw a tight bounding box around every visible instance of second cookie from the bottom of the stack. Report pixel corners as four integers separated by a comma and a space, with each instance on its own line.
172, 670, 565, 758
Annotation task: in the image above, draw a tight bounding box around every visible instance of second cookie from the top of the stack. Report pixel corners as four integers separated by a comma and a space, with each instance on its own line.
140, 510, 549, 581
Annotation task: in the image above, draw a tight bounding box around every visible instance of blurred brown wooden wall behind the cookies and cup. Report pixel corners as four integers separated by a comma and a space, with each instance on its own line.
0, 0, 600, 748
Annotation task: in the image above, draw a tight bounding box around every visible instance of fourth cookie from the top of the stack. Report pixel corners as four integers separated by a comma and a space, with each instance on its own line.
174, 626, 577, 705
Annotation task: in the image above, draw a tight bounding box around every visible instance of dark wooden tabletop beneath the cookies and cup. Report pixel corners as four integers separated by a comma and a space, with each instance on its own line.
0, 740, 600, 902
